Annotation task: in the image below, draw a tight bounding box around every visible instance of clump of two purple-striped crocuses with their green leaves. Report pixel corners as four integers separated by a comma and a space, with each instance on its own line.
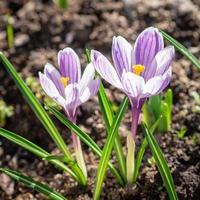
0, 27, 188, 200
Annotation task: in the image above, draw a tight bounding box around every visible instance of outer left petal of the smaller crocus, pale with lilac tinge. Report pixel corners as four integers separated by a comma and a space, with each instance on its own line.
39, 72, 65, 106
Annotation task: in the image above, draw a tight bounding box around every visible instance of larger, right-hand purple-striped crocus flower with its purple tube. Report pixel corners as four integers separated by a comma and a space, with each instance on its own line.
91, 27, 175, 138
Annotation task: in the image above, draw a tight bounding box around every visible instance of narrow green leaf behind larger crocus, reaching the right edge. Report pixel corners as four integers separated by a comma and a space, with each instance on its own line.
159, 30, 200, 70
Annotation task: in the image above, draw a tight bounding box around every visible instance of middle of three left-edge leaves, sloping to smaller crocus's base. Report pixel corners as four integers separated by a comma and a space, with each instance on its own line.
0, 128, 78, 180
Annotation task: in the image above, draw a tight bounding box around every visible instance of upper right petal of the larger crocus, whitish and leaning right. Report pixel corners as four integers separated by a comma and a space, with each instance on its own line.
155, 46, 175, 76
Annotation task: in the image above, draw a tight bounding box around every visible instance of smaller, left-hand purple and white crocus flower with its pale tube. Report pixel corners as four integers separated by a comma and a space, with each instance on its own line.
39, 48, 100, 177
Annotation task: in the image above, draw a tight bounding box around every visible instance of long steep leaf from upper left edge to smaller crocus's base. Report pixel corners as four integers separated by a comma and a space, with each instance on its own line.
0, 52, 86, 185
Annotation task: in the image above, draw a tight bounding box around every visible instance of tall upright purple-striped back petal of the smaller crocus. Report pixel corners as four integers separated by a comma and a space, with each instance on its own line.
58, 48, 81, 83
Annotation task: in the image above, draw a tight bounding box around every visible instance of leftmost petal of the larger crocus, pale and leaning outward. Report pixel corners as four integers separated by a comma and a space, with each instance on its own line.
91, 50, 122, 89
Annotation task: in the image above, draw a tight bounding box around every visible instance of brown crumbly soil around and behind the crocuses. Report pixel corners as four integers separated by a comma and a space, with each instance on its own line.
0, 0, 200, 200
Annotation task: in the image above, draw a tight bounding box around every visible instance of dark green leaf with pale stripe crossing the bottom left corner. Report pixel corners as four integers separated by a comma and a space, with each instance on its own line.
0, 168, 66, 200
